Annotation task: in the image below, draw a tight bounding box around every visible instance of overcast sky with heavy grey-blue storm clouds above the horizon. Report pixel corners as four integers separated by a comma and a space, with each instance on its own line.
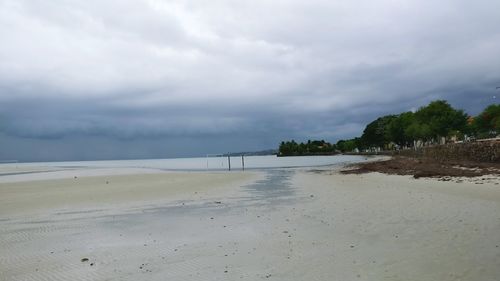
0, 0, 500, 161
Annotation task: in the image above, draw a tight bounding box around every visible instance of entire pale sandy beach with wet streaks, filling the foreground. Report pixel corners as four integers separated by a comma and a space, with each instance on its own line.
0, 165, 500, 281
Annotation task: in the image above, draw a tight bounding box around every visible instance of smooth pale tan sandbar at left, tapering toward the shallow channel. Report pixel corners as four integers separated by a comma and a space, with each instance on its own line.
0, 170, 256, 217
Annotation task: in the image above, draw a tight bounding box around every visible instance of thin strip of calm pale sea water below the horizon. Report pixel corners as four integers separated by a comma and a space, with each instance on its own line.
3, 155, 365, 171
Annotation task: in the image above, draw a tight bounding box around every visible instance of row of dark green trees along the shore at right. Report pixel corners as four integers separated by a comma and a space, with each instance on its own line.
279, 100, 500, 156
